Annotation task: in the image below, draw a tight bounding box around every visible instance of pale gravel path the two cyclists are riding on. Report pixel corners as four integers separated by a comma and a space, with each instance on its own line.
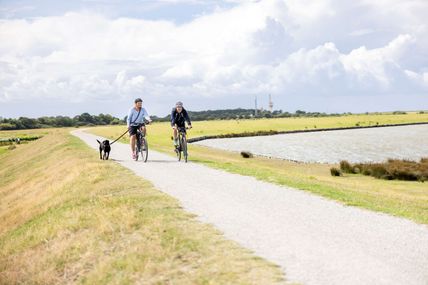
73, 130, 428, 285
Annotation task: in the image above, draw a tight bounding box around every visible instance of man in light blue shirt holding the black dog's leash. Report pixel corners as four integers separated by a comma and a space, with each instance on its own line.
126, 98, 152, 159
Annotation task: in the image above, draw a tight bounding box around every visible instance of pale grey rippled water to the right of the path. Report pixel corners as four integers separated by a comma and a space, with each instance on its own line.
196, 125, 428, 163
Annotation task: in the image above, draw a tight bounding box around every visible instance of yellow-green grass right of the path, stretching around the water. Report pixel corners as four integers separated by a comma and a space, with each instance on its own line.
92, 113, 428, 224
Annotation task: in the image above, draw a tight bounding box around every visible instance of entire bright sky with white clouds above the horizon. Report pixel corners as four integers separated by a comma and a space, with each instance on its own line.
0, 0, 428, 117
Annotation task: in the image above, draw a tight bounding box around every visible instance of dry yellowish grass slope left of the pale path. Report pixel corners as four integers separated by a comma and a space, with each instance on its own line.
0, 129, 281, 284
